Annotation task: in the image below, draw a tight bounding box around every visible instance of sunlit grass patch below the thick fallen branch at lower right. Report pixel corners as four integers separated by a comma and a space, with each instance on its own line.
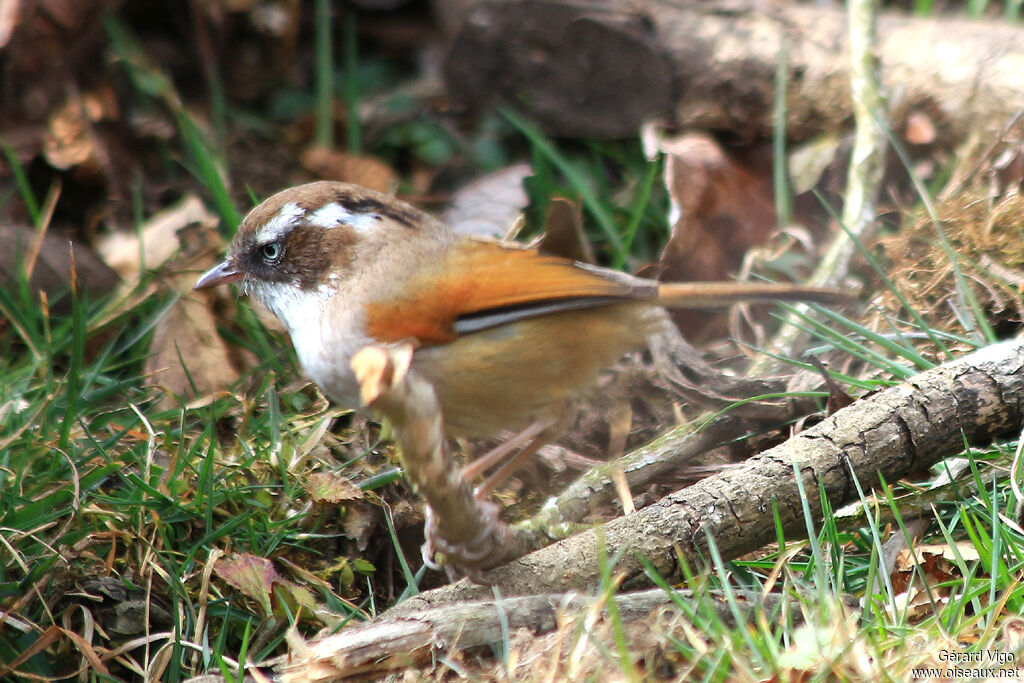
593, 452, 1024, 681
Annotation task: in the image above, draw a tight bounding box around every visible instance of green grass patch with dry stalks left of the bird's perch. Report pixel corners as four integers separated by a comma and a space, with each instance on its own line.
0, 264, 380, 680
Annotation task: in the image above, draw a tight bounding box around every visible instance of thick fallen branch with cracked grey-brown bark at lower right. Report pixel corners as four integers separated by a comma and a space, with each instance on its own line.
391, 340, 1024, 613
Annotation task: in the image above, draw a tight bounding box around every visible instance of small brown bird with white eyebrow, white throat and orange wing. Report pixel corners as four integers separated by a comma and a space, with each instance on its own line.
194, 180, 849, 496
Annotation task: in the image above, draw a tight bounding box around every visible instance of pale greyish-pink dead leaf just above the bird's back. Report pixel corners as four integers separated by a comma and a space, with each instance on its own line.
441, 164, 534, 240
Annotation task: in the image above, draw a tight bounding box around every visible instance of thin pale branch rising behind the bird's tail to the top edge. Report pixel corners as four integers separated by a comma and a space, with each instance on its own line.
503, 1, 887, 549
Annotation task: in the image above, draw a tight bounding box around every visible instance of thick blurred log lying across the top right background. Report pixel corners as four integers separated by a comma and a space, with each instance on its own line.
444, 0, 1024, 143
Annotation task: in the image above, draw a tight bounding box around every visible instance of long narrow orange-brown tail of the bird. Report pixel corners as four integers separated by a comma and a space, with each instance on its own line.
656, 282, 856, 308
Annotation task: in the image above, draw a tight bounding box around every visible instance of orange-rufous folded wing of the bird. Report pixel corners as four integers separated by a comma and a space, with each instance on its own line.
367, 240, 634, 345
